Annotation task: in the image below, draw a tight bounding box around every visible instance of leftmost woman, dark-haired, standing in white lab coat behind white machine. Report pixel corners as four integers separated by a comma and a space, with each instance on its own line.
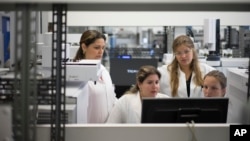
74, 30, 117, 123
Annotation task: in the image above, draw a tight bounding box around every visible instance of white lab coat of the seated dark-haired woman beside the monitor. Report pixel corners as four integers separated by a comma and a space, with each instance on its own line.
107, 92, 168, 123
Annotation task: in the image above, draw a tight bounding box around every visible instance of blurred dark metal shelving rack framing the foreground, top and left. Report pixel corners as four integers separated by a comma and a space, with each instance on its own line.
0, 0, 250, 141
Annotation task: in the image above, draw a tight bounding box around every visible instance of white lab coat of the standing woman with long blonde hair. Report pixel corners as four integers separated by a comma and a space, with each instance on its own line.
158, 63, 215, 97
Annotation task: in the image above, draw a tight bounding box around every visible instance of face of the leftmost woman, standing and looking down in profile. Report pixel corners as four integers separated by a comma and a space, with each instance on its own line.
81, 38, 105, 59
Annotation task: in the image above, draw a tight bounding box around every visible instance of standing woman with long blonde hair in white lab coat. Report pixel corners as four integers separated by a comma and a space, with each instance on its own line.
159, 35, 215, 97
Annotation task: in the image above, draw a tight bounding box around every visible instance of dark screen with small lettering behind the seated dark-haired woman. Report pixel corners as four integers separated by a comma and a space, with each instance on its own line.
110, 58, 158, 86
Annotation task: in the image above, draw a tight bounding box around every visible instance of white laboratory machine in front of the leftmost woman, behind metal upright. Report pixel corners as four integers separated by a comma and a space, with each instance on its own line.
35, 60, 101, 124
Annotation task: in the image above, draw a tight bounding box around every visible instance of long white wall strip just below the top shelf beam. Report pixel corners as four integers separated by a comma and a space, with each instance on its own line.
64, 11, 250, 26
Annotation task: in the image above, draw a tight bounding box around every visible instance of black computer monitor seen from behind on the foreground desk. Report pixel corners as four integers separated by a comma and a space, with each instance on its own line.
141, 98, 229, 123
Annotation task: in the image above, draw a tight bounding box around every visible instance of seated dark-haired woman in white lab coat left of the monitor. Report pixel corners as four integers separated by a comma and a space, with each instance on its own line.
107, 66, 168, 123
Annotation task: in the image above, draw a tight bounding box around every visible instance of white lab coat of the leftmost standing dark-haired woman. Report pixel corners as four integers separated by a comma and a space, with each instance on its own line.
80, 65, 117, 123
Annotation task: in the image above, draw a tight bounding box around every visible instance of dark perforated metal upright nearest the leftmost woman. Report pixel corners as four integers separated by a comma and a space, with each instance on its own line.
51, 4, 67, 141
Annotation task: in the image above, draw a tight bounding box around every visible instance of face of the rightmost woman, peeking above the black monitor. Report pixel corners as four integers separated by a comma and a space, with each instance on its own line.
203, 76, 226, 97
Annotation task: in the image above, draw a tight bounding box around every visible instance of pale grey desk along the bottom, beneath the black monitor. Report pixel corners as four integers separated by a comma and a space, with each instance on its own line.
37, 124, 230, 141
